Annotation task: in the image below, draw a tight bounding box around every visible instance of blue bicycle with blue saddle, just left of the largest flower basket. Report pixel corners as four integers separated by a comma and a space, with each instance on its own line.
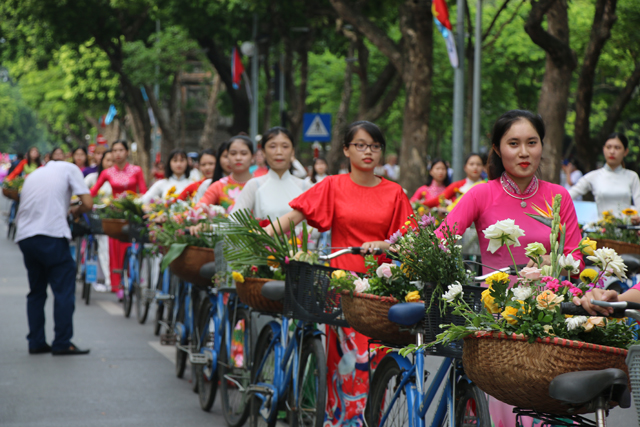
365, 284, 491, 427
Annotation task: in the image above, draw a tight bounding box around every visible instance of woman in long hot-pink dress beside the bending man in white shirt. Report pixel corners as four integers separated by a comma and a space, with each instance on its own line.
91, 141, 147, 299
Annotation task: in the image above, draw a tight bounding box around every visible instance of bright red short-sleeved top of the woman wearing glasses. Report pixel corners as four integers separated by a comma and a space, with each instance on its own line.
289, 174, 413, 273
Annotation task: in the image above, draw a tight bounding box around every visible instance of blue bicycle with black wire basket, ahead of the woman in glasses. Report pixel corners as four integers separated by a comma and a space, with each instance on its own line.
247, 247, 372, 427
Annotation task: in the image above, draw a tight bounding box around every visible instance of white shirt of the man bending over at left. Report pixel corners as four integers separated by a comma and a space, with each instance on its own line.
15, 161, 89, 242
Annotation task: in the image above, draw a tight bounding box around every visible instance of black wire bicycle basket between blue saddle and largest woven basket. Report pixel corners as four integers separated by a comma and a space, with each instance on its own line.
424, 283, 486, 358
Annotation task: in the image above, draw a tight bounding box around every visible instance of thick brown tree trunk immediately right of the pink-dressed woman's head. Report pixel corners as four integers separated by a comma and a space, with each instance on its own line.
525, 0, 577, 182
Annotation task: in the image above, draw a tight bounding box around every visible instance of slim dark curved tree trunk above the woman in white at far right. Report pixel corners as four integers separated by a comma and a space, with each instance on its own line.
574, 0, 618, 172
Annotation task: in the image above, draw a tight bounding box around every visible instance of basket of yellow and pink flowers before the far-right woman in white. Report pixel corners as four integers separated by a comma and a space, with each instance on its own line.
588, 208, 640, 254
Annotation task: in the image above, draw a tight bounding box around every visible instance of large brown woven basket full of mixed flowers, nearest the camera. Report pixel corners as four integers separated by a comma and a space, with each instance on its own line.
429, 195, 635, 415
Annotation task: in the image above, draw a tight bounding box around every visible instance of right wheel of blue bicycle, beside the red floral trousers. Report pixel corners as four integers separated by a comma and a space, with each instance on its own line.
289, 337, 327, 427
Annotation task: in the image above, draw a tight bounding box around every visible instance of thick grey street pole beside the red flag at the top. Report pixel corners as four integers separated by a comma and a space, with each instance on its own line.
451, 0, 464, 181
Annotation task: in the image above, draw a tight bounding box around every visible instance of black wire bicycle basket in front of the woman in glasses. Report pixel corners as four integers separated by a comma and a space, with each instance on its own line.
284, 261, 349, 326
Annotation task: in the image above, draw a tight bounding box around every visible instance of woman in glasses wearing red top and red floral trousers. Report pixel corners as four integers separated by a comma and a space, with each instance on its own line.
267, 121, 413, 427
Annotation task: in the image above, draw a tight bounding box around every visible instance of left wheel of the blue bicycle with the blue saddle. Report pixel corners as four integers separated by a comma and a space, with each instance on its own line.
364, 357, 410, 427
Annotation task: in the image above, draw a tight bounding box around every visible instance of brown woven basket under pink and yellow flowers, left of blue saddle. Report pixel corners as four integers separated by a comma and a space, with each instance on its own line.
341, 291, 416, 346
